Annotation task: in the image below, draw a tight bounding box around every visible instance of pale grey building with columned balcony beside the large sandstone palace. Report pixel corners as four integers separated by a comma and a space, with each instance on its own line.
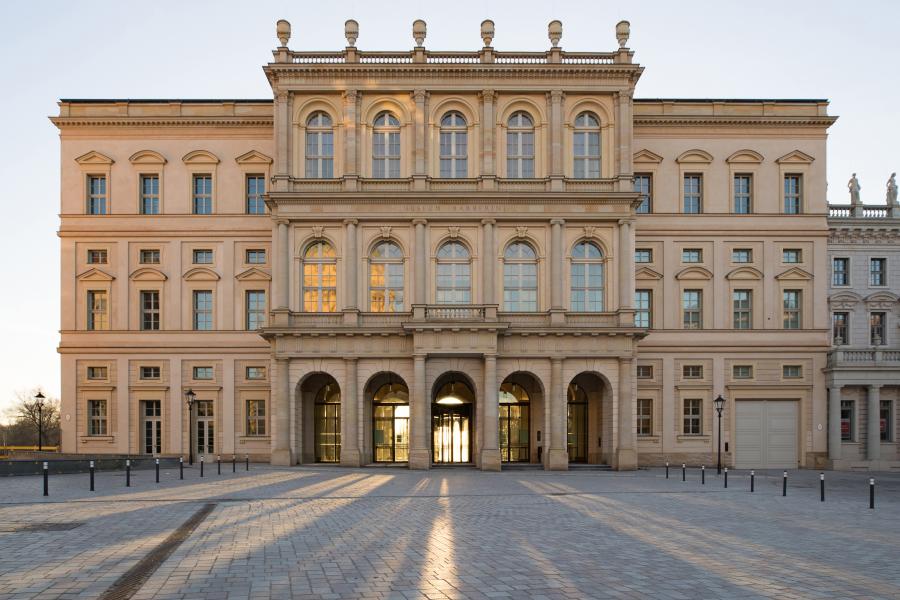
825, 197, 900, 470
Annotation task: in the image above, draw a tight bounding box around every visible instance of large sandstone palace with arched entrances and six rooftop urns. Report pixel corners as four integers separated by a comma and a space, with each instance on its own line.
53, 21, 835, 469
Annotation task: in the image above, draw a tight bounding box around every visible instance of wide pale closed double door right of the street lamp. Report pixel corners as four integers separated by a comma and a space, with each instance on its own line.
734, 400, 798, 469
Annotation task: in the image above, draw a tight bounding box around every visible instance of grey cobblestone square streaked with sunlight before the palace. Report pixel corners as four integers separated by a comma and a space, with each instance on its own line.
0, 464, 900, 600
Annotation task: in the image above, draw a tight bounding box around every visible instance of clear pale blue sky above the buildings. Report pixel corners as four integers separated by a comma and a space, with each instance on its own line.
0, 0, 900, 420
